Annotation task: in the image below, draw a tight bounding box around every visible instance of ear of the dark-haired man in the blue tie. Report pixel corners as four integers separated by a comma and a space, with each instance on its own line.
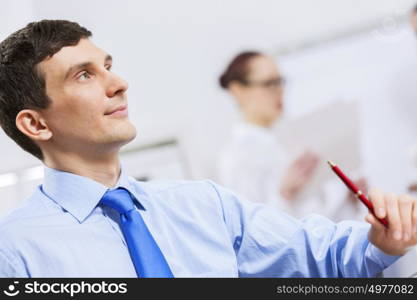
16, 109, 52, 141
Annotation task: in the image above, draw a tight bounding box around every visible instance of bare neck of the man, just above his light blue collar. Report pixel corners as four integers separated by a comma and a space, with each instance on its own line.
44, 153, 120, 187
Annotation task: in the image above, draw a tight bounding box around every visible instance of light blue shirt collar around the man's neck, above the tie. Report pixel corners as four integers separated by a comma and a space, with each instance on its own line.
42, 166, 147, 223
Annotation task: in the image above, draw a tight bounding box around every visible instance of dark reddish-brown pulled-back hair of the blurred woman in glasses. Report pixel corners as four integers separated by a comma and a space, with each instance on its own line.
219, 51, 262, 89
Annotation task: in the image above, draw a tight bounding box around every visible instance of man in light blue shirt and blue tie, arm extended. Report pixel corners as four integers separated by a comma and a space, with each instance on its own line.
0, 20, 417, 277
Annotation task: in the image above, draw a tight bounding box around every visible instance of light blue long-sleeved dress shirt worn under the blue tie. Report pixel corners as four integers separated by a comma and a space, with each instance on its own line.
0, 167, 398, 277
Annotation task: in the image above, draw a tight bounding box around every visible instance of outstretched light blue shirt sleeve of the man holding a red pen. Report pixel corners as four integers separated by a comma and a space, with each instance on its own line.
208, 180, 401, 277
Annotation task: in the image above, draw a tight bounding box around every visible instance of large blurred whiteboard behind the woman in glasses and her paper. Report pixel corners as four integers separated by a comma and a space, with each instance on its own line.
278, 24, 417, 193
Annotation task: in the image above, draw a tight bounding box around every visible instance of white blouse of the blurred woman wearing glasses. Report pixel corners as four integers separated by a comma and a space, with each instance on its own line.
218, 121, 291, 212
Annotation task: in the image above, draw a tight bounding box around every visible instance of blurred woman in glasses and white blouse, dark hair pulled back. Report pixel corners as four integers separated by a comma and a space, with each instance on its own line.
219, 52, 318, 214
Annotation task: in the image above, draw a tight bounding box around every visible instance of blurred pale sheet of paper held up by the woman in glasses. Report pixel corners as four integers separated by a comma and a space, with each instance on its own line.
277, 101, 361, 198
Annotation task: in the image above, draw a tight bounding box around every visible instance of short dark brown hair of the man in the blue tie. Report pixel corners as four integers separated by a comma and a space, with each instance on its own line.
0, 20, 91, 160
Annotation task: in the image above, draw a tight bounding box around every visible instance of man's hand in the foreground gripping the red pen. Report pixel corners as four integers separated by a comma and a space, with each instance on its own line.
365, 189, 417, 255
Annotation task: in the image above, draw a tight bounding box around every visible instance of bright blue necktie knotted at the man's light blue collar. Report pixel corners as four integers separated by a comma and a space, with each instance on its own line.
100, 188, 173, 278
